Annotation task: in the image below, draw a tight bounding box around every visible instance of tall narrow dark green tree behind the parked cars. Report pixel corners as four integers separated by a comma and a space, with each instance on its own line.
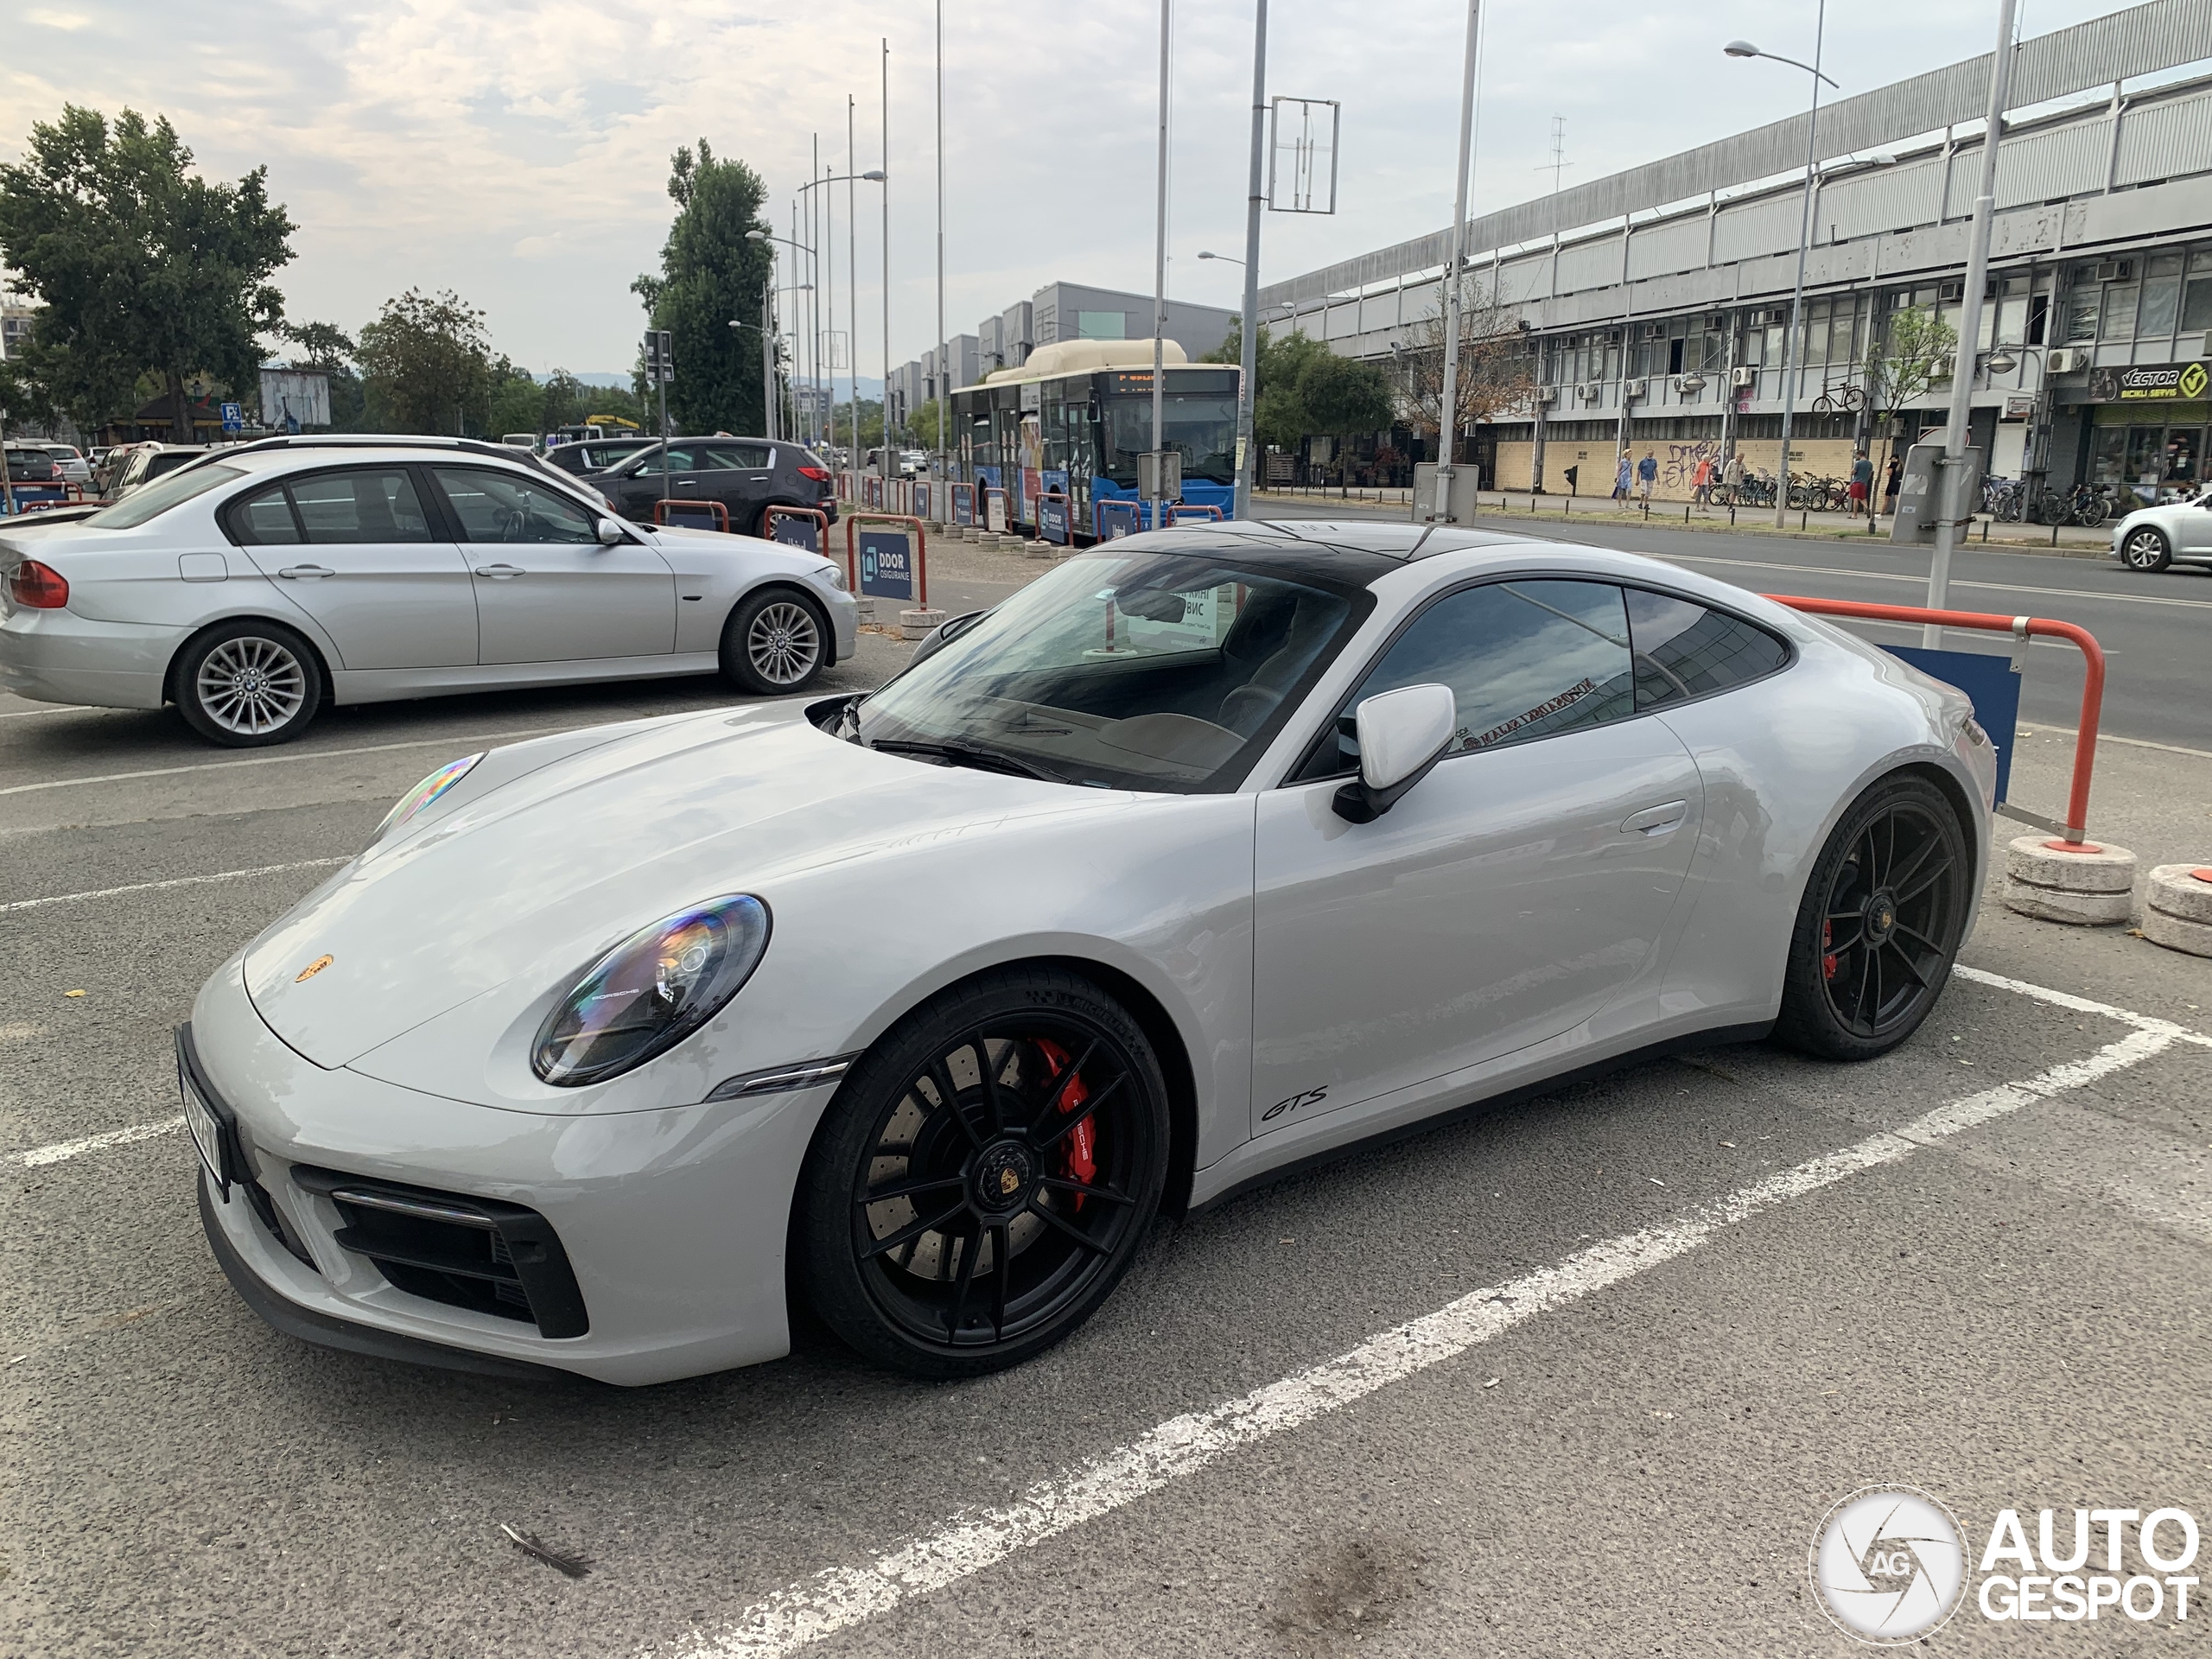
631, 139, 772, 434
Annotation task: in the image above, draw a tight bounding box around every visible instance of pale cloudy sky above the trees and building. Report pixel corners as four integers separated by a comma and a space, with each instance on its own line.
0, 0, 2117, 376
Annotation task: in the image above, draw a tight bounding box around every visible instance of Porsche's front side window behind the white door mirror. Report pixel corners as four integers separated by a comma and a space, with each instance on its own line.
1305, 582, 1635, 777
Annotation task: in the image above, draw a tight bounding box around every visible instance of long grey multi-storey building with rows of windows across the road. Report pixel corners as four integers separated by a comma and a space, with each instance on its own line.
1261, 0, 2212, 498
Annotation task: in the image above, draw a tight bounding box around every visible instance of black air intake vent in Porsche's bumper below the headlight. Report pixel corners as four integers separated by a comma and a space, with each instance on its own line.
292, 1164, 591, 1336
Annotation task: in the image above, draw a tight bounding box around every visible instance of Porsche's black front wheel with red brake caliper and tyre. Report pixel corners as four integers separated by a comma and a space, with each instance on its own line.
791, 969, 1168, 1378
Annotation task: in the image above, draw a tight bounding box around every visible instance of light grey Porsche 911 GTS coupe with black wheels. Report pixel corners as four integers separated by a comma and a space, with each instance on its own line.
177, 524, 1995, 1382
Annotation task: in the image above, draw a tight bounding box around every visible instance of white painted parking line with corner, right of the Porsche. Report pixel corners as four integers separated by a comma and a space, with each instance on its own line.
664, 995, 2196, 1659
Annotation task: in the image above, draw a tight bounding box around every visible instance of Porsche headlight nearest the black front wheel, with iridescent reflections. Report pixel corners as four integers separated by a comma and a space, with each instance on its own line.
531, 893, 767, 1089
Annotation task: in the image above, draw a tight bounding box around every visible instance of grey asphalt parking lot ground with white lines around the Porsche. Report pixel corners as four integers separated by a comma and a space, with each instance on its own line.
0, 526, 2212, 1659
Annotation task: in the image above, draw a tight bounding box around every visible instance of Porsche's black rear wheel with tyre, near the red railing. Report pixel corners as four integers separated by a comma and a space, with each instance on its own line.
1774, 777, 1974, 1059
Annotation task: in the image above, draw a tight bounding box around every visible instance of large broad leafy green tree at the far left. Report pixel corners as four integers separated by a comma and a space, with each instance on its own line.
0, 104, 294, 440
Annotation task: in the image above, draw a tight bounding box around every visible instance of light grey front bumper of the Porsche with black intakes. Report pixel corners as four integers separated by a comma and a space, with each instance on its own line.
186, 957, 836, 1385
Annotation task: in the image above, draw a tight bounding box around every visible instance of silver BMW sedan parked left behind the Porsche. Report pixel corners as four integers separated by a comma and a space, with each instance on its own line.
0, 438, 858, 746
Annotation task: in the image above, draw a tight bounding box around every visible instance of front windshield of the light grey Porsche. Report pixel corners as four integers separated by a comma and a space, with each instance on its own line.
856, 548, 1371, 794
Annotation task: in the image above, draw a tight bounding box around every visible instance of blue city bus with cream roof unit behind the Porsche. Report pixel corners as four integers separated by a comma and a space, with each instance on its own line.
949, 340, 1239, 544
